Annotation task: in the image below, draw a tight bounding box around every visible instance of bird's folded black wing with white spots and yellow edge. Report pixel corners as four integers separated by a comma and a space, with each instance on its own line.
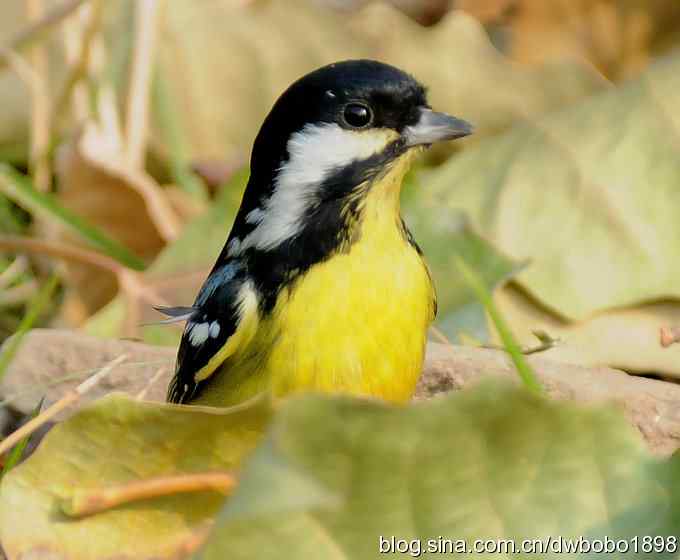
167, 262, 256, 403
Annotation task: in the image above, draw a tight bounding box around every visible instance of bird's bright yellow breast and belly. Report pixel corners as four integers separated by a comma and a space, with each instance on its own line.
196, 153, 434, 405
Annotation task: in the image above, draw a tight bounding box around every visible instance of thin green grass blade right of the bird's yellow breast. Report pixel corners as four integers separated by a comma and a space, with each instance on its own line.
455, 256, 543, 395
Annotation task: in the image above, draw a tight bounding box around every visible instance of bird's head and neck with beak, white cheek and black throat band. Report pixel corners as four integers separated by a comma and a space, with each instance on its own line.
218, 60, 471, 304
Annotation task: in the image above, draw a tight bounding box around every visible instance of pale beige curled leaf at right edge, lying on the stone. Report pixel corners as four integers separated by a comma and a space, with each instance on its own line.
489, 285, 680, 378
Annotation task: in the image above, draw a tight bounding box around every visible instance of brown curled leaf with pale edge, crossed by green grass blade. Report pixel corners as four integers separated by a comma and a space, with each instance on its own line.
58, 123, 186, 325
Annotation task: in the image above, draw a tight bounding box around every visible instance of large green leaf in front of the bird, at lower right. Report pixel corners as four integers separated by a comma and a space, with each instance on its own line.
196, 383, 680, 560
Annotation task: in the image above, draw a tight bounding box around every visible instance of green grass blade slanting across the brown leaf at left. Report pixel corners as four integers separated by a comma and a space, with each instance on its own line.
0, 163, 146, 270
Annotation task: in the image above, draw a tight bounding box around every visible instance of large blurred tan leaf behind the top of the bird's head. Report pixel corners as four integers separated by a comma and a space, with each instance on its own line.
155, 0, 606, 160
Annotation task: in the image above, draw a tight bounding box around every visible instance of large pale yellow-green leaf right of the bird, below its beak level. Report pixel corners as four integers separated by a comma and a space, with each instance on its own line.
422, 52, 680, 322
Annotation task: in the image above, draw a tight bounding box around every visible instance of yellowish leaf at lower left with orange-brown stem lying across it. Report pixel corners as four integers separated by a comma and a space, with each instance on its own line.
0, 394, 271, 560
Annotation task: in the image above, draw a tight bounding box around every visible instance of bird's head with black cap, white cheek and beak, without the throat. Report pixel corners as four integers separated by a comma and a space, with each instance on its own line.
231, 60, 471, 249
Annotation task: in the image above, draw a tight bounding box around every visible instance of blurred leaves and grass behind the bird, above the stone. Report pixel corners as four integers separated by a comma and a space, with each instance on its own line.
0, 0, 680, 378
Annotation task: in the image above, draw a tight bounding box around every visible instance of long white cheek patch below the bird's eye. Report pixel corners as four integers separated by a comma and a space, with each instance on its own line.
240, 123, 395, 251
